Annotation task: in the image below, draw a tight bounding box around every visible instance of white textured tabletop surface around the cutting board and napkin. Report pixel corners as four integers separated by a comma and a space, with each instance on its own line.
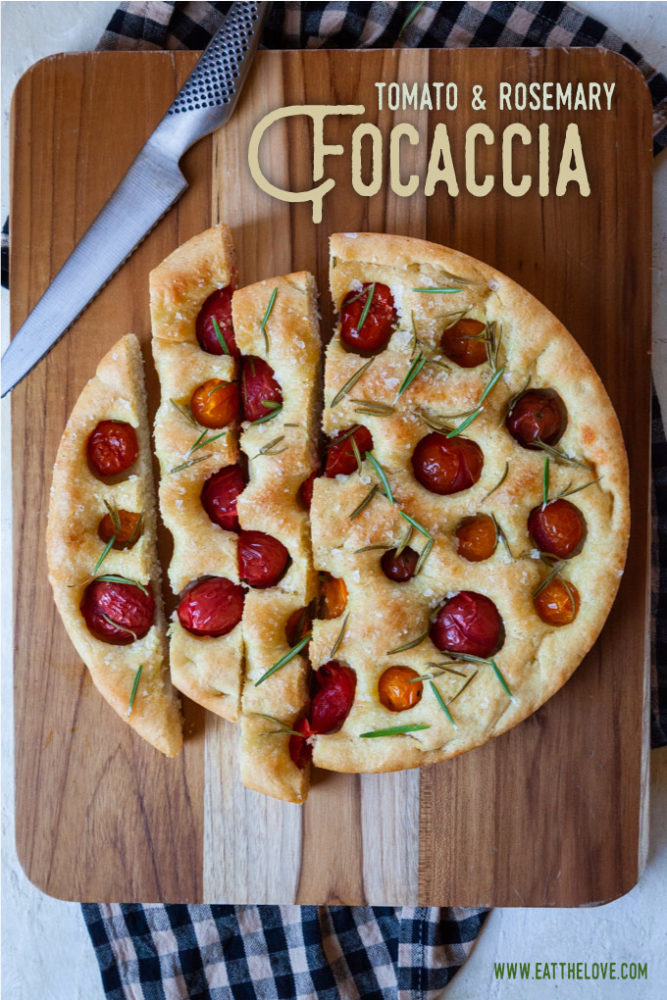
0, 0, 667, 1000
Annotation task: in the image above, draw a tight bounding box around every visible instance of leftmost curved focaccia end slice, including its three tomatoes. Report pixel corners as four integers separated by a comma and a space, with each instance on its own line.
46, 334, 182, 756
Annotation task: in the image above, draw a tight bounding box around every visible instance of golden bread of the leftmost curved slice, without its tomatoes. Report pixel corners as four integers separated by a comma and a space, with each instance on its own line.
46, 334, 182, 756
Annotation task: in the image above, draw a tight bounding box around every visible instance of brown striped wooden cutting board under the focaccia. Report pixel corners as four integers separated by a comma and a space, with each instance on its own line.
11, 50, 651, 906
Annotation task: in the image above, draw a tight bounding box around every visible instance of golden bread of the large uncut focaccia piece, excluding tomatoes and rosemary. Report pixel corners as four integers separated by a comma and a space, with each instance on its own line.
310, 233, 630, 771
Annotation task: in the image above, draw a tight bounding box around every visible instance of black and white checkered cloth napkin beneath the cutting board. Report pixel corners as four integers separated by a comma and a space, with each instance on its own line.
23, 0, 667, 1000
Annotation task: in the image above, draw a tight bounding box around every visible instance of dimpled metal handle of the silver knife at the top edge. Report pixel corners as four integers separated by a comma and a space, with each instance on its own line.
167, 0, 270, 124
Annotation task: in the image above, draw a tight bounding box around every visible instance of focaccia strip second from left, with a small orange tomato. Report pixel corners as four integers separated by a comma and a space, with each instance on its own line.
150, 225, 243, 719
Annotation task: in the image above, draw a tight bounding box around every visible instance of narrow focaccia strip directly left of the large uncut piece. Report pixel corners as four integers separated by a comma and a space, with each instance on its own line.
232, 272, 320, 802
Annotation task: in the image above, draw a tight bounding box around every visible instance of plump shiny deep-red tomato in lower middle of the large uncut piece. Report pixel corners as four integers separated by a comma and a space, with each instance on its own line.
429, 590, 505, 659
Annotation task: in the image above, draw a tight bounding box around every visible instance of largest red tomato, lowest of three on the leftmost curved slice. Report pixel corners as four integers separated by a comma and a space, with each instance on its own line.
81, 580, 155, 646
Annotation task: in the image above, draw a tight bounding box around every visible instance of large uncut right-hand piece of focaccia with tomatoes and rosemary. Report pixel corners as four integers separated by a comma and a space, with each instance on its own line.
310, 233, 629, 772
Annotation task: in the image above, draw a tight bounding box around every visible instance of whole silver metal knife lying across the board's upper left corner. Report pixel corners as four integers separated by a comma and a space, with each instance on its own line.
0, 0, 270, 396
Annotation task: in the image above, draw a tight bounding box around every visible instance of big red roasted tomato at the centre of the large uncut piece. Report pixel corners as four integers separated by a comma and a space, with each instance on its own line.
412, 431, 484, 496
